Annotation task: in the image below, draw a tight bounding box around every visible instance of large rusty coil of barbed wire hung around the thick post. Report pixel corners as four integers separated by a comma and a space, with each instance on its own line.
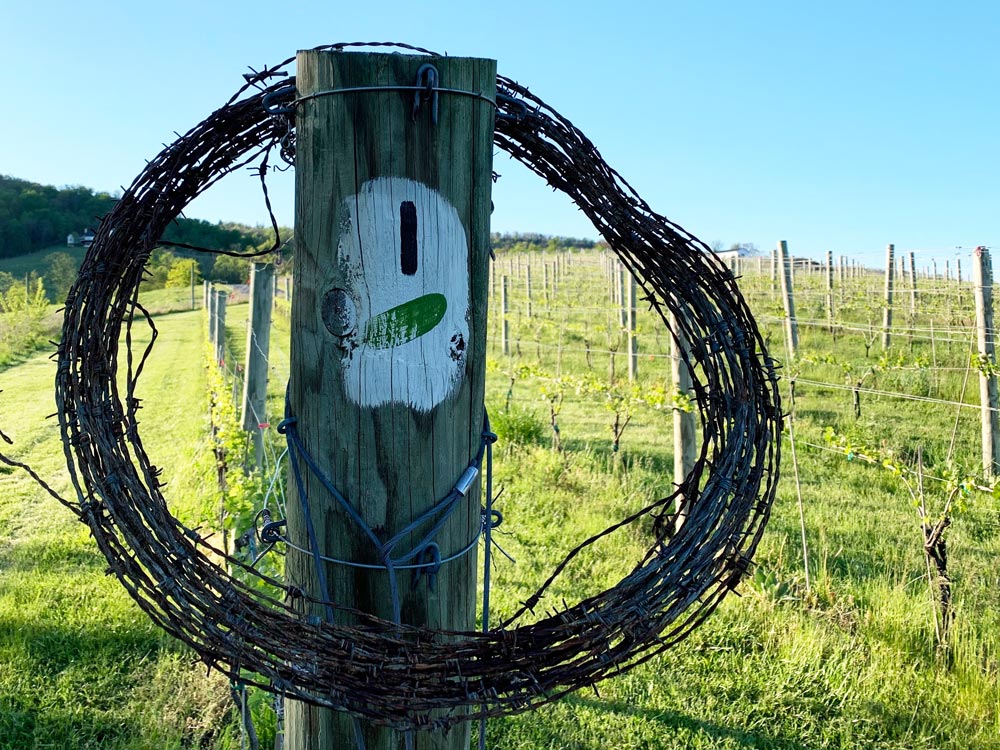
56, 44, 781, 729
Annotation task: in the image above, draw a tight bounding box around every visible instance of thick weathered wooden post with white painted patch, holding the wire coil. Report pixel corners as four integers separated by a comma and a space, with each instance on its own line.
286, 51, 496, 750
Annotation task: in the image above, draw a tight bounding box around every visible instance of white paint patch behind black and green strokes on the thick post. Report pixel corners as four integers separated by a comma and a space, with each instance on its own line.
337, 177, 469, 412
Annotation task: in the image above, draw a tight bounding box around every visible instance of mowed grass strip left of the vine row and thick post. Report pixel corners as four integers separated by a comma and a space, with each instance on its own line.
0, 312, 230, 750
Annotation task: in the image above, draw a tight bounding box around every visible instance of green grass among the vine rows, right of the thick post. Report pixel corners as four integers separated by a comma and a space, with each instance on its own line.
215, 254, 1000, 750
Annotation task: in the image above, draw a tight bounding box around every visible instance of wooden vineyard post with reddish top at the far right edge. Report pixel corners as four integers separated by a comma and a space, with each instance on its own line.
972, 247, 1000, 479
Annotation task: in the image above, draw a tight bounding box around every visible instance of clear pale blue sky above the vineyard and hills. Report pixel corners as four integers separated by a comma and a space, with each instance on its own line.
0, 0, 1000, 264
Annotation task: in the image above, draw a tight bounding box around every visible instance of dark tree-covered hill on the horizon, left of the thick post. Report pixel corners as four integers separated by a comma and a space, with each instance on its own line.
0, 175, 284, 259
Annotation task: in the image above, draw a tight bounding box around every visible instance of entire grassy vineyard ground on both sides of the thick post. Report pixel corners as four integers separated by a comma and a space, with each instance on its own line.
0, 253, 1000, 750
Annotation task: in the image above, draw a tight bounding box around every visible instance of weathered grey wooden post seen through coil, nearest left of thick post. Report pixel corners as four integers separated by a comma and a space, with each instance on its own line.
240, 263, 274, 469
